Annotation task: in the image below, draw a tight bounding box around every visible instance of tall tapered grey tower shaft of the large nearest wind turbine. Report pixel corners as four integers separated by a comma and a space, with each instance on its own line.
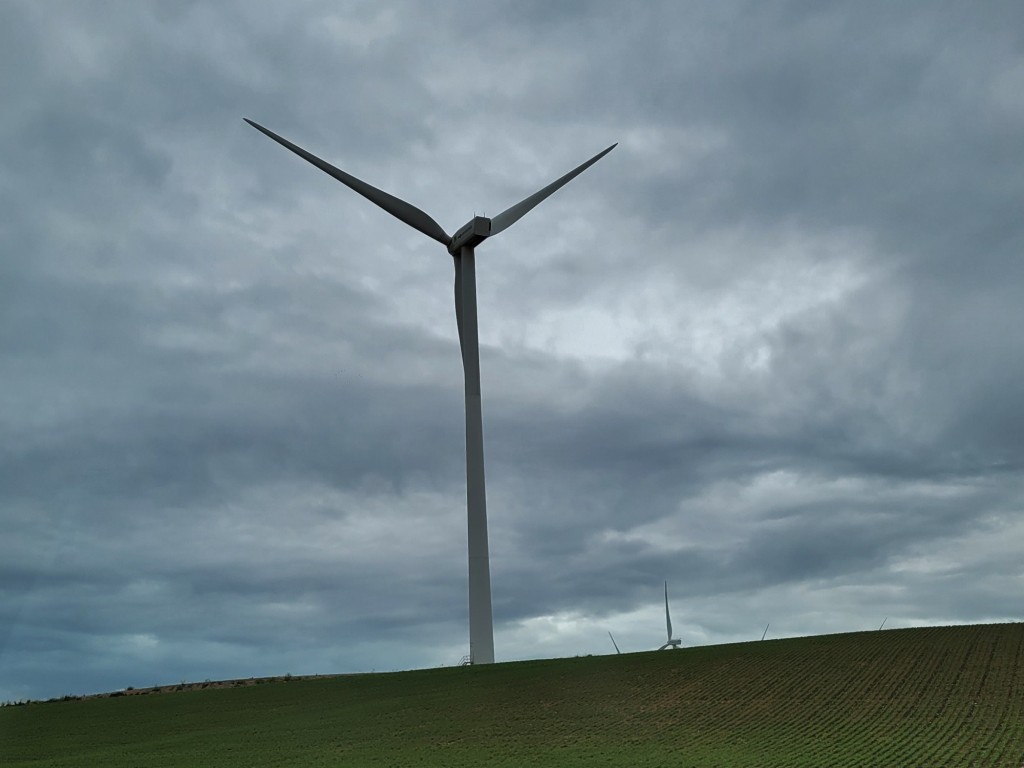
455, 246, 495, 665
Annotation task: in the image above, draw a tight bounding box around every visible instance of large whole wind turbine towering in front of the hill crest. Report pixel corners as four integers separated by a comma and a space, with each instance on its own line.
243, 118, 614, 665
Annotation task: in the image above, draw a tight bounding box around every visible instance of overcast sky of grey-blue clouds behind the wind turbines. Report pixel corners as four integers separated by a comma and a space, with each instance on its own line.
0, 0, 1024, 700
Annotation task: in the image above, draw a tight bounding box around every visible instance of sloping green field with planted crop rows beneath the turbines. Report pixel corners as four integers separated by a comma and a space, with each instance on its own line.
0, 624, 1024, 768
